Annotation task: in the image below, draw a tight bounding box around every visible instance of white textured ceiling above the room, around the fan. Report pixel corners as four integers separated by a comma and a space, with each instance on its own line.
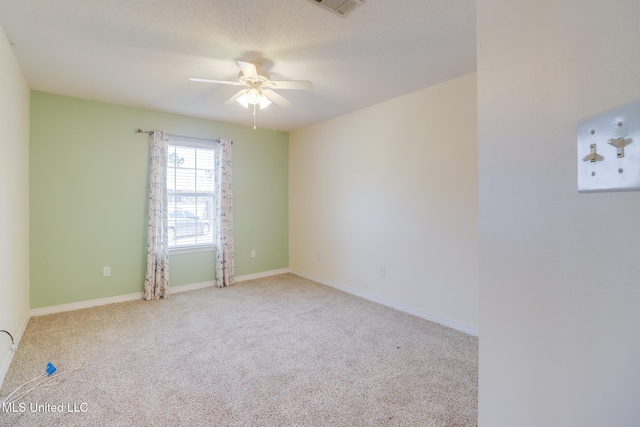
0, 0, 476, 131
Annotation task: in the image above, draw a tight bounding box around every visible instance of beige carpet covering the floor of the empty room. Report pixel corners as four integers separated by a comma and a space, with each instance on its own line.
0, 274, 478, 427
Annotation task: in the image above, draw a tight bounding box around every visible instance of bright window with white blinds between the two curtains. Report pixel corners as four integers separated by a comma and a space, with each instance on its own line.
167, 138, 215, 250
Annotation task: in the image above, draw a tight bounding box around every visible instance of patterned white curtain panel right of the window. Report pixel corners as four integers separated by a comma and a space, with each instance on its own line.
213, 139, 234, 288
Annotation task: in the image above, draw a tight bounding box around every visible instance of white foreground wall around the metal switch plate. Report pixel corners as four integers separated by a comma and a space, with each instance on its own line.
477, 0, 640, 427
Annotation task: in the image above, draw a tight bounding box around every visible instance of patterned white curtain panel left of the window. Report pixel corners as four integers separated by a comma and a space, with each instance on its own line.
144, 130, 169, 300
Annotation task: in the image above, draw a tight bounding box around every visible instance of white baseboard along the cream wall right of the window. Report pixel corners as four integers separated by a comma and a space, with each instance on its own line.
291, 269, 478, 337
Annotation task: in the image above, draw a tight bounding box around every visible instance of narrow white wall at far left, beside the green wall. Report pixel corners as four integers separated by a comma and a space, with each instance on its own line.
0, 27, 29, 384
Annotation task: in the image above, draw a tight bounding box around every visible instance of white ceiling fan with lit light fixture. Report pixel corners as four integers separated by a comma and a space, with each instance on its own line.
189, 61, 313, 115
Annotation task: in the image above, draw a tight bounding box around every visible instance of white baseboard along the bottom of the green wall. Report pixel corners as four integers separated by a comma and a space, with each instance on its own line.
25, 268, 289, 320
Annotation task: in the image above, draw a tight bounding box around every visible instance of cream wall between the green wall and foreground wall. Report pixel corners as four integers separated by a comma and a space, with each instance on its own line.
289, 74, 478, 334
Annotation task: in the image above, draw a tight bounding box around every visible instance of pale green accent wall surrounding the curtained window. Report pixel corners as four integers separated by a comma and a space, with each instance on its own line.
29, 91, 289, 308
